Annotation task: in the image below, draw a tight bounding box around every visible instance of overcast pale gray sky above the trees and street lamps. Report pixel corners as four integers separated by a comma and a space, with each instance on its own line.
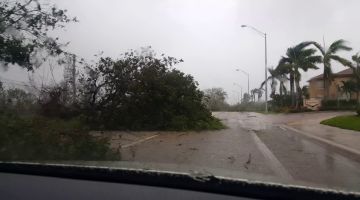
0, 0, 360, 102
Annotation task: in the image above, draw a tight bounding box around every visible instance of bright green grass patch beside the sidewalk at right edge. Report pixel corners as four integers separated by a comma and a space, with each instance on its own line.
320, 115, 360, 131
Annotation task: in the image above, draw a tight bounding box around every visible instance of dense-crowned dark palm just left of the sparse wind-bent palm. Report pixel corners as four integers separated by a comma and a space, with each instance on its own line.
279, 42, 322, 109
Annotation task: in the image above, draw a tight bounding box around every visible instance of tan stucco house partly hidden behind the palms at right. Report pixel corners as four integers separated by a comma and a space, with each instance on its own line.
304, 68, 356, 110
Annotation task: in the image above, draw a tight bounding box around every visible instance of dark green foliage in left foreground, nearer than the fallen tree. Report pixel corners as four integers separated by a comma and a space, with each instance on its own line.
0, 114, 116, 160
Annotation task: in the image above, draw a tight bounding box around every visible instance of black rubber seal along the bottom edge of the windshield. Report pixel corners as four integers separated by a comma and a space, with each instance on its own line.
0, 161, 360, 200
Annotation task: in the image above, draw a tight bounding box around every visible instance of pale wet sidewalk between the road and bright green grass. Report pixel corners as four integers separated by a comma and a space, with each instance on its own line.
286, 113, 360, 152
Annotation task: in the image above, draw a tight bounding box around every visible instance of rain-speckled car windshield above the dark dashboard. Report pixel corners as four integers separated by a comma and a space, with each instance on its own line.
0, 0, 360, 195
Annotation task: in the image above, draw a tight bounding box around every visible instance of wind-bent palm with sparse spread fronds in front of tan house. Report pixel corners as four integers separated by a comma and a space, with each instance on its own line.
312, 39, 352, 100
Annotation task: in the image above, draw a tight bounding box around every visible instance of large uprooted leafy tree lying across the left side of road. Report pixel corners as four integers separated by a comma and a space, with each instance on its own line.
80, 47, 222, 130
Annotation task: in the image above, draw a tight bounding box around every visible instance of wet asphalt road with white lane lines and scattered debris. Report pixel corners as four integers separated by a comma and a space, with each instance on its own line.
121, 112, 360, 192
